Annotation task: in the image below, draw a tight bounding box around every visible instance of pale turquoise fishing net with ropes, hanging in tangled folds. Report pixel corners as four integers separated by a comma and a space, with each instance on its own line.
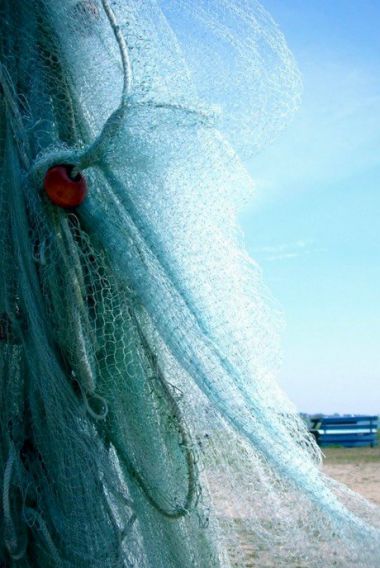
0, 0, 380, 568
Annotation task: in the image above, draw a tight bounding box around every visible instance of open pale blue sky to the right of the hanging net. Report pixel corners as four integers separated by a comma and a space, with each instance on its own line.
241, 0, 380, 413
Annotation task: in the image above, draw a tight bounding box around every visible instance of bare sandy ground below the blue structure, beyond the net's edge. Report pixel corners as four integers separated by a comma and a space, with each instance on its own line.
323, 446, 380, 505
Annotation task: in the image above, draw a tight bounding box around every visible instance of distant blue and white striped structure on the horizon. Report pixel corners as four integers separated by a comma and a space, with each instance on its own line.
310, 414, 379, 448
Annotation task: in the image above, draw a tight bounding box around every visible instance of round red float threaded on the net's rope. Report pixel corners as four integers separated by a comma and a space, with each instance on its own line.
44, 164, 87, 209
